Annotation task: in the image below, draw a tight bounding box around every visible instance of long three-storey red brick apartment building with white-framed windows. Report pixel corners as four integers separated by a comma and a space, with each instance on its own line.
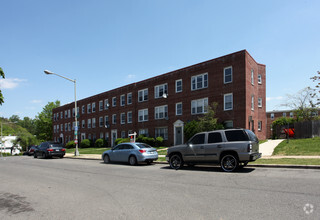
53, 50, 267, 146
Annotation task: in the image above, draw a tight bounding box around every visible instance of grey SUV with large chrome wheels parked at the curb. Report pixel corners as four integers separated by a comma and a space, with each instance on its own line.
166, 129, 261, 172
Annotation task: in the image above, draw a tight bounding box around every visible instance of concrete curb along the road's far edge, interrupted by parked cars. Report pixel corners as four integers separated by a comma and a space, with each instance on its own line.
64, 156, 320, 169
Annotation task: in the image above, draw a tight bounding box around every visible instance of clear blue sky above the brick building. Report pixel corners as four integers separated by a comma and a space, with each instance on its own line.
0, 0, 320, 118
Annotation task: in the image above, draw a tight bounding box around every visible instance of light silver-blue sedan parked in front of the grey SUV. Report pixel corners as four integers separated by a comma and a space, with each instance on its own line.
102, 143, 158, 165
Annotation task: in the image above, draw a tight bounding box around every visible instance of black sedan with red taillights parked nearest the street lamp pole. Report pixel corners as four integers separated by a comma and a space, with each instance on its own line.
33, 141, 66, 158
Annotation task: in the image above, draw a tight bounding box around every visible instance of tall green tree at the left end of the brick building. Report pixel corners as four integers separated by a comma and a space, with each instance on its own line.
35, 100, 60, 141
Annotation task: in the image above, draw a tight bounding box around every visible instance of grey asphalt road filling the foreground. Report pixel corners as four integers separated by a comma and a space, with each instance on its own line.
0, 156, 320, 220
